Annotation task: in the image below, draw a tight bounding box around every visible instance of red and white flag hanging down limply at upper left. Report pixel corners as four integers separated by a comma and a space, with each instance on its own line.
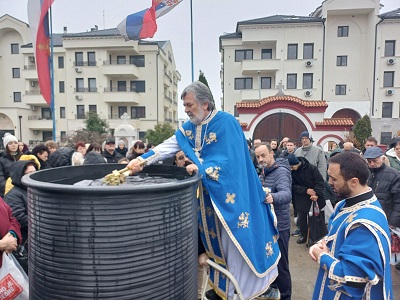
28, 0, 54, 105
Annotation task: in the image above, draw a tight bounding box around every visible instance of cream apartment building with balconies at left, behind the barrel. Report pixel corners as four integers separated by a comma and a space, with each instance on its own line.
0, 15, 181, 148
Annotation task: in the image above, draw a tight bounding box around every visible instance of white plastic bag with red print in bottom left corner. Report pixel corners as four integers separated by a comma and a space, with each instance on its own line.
0, 253, 29, 300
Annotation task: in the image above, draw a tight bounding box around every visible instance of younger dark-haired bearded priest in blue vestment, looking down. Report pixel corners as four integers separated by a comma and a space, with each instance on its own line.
309, 152, 394, 300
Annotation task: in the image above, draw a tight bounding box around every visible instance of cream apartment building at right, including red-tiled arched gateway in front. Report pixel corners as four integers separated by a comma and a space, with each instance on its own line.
220, 0, 400, 145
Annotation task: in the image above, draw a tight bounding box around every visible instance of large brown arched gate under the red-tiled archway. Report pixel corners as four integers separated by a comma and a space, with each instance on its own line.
253, 112, 307, 146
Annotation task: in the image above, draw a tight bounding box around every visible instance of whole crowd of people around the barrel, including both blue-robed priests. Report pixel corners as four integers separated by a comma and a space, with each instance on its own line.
0, 82, 400, 300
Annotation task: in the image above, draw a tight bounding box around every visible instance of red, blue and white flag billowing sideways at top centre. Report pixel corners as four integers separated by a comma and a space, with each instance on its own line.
117, 0, 183, 41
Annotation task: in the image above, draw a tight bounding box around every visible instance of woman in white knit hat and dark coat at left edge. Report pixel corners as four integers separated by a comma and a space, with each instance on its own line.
0, 134, 22, 197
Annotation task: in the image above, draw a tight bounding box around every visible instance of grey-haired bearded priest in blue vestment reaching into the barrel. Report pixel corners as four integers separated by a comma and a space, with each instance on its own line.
128, 81, 280, 299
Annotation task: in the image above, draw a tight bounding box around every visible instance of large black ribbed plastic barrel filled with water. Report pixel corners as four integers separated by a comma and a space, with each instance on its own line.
23, 164, 200, 300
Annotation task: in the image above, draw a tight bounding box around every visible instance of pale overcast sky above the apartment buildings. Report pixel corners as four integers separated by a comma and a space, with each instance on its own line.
0, 0, 400, 117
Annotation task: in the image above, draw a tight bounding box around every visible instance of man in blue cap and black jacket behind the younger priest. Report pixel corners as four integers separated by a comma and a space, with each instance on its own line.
364, 147, 400, 227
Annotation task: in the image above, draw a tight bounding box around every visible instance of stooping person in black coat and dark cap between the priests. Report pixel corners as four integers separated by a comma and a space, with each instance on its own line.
288, 154, 326, 244
